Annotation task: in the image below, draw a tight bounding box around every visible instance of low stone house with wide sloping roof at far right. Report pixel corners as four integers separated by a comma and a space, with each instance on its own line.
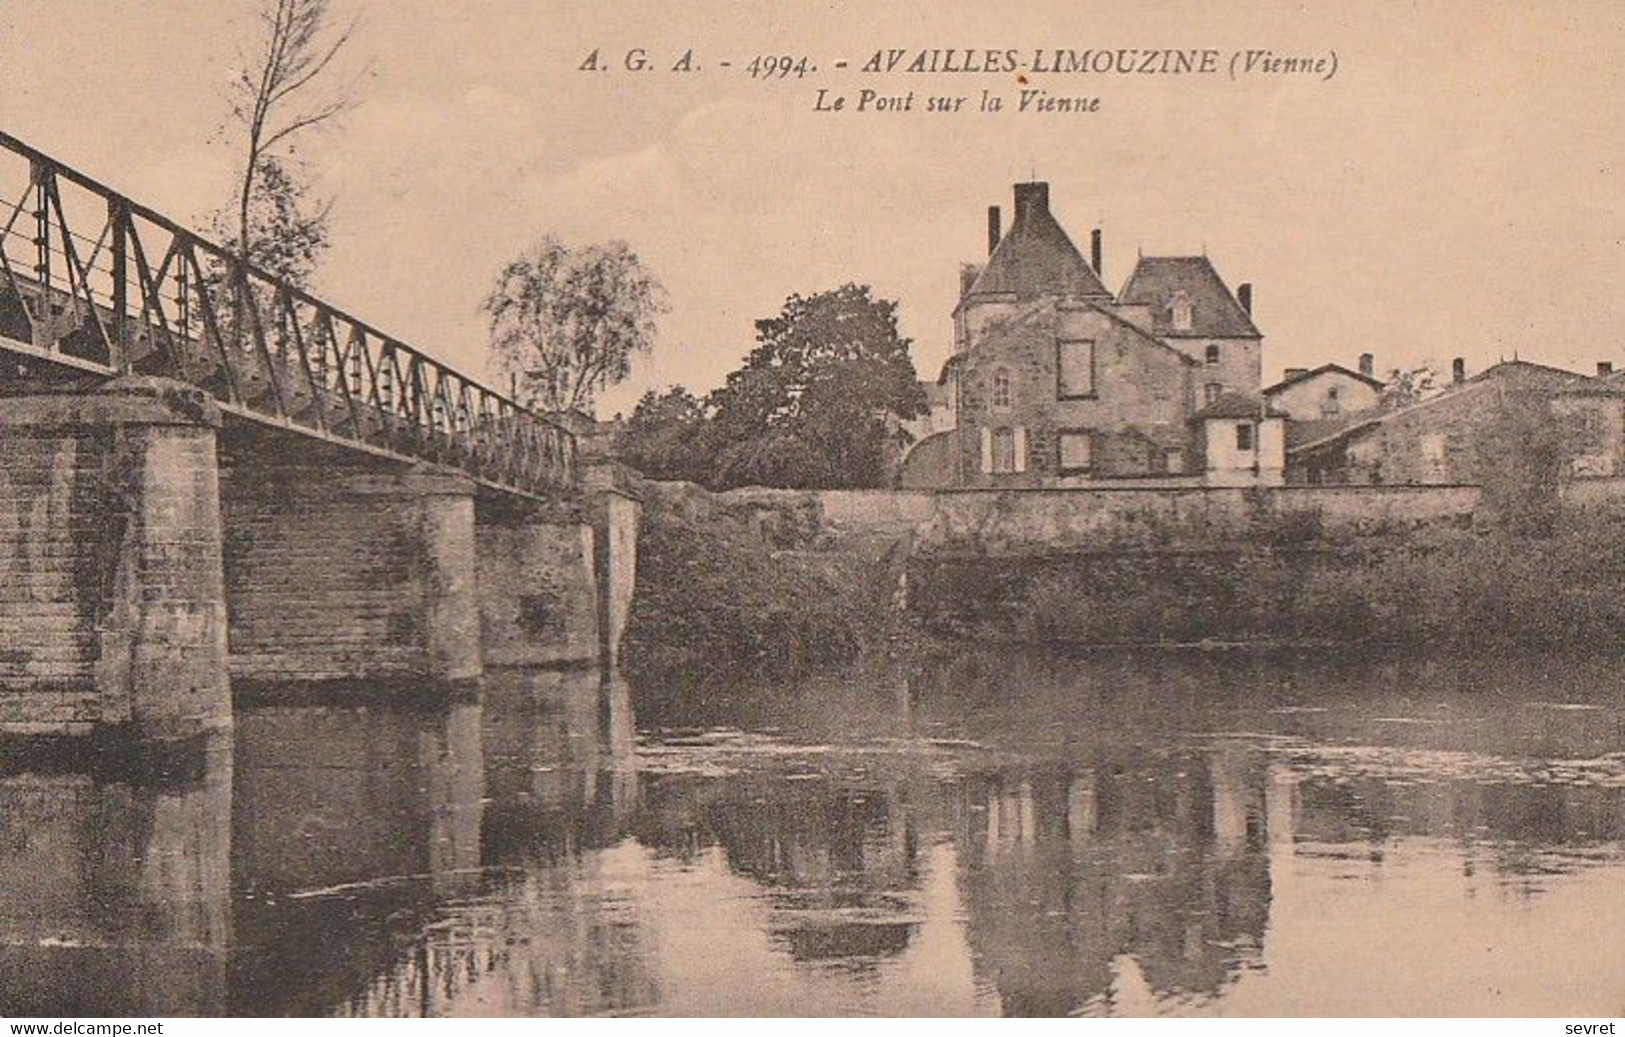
1287, 361, 1625, 484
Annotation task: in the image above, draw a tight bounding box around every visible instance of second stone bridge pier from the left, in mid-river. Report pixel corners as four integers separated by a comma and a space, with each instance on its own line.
221, 463, 479, 683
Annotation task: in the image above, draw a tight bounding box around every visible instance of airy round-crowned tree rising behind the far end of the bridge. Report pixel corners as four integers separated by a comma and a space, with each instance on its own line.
481, 234, 666, 411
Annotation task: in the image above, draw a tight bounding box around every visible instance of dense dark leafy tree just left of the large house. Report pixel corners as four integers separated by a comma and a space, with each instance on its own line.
710, 284, 926, 488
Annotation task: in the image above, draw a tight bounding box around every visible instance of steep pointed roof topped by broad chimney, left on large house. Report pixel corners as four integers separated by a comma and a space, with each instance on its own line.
962, 184, 1112, 302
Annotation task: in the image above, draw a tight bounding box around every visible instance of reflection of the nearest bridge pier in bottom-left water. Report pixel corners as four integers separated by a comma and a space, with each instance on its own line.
0, 743, 232, 1017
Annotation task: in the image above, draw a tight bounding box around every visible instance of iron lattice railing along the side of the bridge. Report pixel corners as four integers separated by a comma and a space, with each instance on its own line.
0, 133, 577, 494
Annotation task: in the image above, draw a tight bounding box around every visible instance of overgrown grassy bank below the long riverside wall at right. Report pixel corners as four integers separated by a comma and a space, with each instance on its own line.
910, 515, 1625, 650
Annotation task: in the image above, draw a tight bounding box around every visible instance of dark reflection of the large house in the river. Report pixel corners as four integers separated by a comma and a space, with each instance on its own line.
956, 749, 1269, 1016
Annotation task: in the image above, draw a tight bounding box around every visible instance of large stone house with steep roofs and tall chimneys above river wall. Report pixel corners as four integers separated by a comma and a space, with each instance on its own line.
900, 182, 1284, 488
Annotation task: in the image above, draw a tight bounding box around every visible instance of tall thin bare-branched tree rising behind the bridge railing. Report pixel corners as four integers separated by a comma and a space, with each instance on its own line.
231, 0, 356, 281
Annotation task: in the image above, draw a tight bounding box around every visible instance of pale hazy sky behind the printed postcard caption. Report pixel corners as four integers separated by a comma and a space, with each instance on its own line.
0, 0, 1625, 416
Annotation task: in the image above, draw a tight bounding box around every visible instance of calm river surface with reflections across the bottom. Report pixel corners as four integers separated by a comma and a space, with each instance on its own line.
0, 653, 1625, 1016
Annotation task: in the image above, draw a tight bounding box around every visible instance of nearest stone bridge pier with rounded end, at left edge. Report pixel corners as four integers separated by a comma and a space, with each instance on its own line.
0, 377, 231, 740
